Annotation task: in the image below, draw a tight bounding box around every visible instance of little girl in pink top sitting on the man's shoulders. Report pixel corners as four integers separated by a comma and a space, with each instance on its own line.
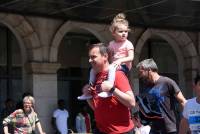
78, 13, 134, 100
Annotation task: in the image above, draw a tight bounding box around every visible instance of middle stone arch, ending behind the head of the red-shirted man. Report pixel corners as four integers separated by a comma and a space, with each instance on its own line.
49, 21, 106, 62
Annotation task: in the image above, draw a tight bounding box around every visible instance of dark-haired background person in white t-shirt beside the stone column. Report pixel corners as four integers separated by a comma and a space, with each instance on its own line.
52, 99, 69, 134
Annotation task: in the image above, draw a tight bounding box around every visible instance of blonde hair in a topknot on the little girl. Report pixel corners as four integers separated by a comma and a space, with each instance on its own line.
110, 13, 130, 32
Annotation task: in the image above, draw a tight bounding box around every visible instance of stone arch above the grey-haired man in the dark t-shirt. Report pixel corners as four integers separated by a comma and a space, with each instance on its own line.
135, 29, 199, 95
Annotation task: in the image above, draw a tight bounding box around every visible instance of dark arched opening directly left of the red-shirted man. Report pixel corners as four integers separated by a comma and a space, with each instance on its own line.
57, 28, 99, 130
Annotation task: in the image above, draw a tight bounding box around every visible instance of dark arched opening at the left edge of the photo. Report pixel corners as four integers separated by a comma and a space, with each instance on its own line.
0, 25, 23, 133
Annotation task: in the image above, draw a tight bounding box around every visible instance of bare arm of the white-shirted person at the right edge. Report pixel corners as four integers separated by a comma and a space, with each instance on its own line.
179, 117, 189, 134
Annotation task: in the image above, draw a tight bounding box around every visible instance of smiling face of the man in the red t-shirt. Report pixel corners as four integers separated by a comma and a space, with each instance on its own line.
89, 47, 108, 72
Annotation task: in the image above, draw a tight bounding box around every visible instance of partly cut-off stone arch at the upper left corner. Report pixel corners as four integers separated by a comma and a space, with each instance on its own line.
0, 13, 42, 62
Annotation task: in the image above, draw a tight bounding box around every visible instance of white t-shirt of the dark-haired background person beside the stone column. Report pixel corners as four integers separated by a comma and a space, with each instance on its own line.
53, 109, 69, 134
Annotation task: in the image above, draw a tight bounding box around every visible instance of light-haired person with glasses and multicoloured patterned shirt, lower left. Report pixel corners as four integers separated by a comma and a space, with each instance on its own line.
3, 96, 45, 134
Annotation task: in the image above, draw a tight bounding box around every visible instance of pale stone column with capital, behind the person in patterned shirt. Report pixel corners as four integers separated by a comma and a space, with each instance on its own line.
26, 62, 60, 134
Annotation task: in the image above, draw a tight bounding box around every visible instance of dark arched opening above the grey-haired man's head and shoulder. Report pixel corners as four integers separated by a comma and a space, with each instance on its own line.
139, 36, 179, 83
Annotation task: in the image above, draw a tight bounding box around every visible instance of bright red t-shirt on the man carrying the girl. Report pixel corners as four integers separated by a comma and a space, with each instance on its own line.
93, 71, 134, 134
